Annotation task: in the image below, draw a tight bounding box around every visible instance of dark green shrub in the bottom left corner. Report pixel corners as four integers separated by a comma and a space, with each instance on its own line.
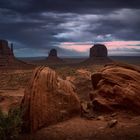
0, 107, 22, 140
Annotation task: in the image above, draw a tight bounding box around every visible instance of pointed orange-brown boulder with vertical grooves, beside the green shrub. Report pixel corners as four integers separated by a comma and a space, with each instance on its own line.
21, 67, 80, 132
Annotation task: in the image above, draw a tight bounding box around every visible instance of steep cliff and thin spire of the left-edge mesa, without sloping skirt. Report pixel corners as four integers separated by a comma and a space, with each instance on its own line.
0, 40, 14, 66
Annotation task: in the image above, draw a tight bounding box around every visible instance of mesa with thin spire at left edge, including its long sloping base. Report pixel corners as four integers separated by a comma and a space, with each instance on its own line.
0, 40, 32, 67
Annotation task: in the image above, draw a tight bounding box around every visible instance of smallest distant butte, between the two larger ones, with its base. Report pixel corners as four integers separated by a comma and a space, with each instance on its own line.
47, 49, 64, 64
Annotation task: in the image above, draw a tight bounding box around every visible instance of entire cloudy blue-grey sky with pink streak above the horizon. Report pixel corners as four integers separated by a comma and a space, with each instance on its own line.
0, 0, 140, 57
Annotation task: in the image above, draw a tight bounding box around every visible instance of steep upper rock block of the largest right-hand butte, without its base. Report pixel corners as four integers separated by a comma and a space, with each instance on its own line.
89, 44, 108, 58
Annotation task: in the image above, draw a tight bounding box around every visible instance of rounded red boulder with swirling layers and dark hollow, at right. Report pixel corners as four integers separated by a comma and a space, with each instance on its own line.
92, 64, 140, 113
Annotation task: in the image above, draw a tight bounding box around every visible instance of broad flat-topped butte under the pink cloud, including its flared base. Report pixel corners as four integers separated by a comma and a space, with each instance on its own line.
84, 44, 112, 64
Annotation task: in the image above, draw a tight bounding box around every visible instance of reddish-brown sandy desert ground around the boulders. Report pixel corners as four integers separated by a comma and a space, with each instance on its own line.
0, 56, 140, 140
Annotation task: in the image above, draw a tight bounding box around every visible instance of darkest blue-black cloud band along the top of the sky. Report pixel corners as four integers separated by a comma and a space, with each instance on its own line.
0, 0, 140, 13
